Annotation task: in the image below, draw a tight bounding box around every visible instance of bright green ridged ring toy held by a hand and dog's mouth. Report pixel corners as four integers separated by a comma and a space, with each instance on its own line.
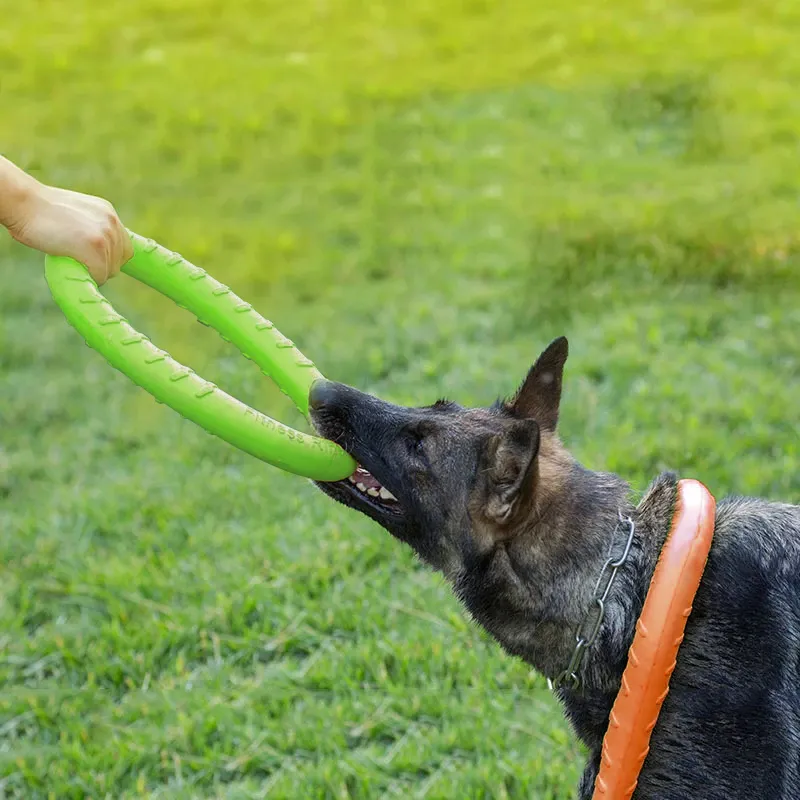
45, 233, 357, 481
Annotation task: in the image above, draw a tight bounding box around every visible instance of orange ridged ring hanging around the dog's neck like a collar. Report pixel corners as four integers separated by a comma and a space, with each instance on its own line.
593, 480, 716, 800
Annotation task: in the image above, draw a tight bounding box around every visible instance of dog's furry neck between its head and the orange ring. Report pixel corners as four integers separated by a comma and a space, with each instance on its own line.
455, 446, 677, 747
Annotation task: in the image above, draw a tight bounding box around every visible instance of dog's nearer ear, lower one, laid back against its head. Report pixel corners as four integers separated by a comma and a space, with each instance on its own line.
484, 419, 539, 525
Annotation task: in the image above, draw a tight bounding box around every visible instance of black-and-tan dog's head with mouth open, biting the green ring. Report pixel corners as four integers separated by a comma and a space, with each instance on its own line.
310, 337, 568, 573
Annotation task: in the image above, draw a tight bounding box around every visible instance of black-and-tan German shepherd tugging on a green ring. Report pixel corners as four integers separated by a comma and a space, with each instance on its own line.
310, 338, 800, 800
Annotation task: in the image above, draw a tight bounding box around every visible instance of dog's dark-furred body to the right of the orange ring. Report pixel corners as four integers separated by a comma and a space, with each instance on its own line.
634, 498, 800, 800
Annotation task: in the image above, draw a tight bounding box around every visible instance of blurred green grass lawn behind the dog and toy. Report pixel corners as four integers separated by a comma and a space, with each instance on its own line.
0, 0, 800, 800
